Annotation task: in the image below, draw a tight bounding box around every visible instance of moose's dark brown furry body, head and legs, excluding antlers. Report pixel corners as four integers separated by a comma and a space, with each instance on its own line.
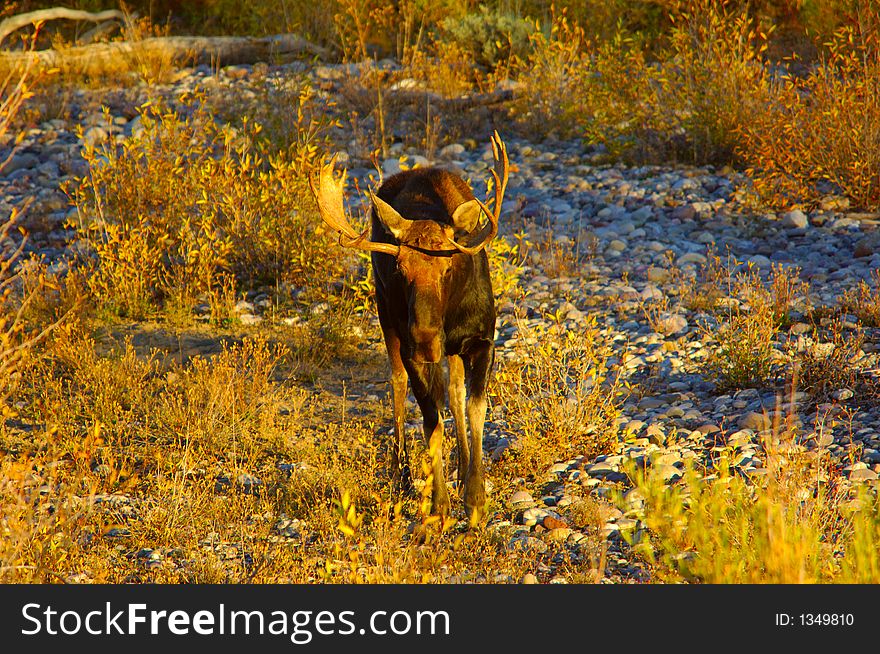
372, 168, 495, 517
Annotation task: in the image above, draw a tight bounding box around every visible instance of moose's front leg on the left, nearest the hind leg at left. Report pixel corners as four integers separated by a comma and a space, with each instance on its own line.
407, 362, 450, 516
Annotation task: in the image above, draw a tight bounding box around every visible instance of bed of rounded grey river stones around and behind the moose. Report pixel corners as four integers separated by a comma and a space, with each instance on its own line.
0, 61, 880, 581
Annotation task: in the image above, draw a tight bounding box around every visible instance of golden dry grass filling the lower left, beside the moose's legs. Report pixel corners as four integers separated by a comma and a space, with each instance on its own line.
0, 318, 612, 583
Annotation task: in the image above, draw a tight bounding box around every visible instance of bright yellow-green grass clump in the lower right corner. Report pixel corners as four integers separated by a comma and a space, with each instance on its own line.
634, 422, 880, 584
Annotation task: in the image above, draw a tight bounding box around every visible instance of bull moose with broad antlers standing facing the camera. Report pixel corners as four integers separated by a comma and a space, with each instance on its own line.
310, 132, 509, 522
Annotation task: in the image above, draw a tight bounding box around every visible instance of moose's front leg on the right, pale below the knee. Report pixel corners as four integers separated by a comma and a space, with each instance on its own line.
464, 341, 495, 524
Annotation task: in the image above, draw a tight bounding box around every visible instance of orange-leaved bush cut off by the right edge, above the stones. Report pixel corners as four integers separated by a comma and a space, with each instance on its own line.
739, 12, 880, 210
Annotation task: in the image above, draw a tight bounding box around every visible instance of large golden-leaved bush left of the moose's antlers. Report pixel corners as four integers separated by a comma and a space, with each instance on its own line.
71, 89, 334, 318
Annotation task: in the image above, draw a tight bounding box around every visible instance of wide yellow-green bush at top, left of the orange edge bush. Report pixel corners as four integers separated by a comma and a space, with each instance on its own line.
520, 0, 769, 163
